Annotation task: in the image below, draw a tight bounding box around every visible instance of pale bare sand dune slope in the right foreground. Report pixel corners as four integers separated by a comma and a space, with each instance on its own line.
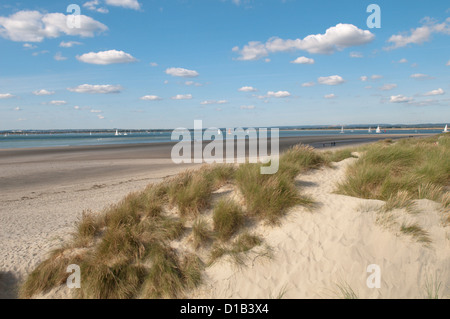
192, 159, 450, 298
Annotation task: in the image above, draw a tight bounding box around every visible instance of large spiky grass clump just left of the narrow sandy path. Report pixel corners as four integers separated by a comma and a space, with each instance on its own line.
236, 162, 312, 224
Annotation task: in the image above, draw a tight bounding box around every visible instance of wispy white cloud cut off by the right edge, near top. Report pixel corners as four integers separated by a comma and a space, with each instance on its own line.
385, 18, 450, 50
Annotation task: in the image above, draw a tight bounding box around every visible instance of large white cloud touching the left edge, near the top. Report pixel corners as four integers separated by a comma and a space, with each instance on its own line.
0, 11, 108, 42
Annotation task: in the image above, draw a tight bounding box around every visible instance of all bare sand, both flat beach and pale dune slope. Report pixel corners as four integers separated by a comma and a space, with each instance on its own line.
0, 135, 442, 298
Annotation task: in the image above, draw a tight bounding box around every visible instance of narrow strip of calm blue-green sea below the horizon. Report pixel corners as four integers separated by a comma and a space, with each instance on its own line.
0, 130, 442, 149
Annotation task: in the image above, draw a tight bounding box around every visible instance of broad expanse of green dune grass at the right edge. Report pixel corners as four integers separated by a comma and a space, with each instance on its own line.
338, 135, 450, 206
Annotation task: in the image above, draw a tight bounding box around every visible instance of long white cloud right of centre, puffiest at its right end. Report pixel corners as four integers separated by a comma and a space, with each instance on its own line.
233, 23, 375, 61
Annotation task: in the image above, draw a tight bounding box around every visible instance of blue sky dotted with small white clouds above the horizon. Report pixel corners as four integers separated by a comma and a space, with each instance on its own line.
0, 0, 450, 130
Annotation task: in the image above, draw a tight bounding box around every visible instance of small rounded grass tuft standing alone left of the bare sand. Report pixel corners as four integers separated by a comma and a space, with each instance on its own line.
213, 199, 245, 240
